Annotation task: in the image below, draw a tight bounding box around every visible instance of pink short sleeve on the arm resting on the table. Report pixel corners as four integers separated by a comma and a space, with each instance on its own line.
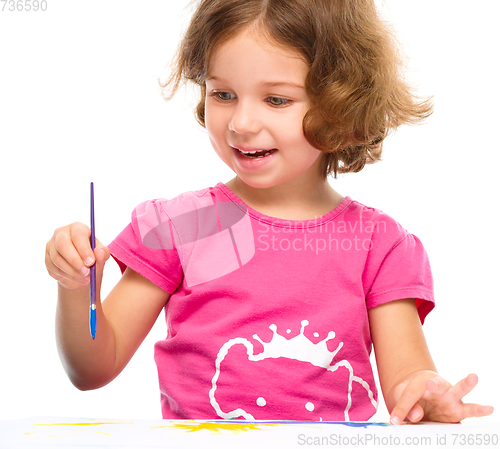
366, 231, 434, 323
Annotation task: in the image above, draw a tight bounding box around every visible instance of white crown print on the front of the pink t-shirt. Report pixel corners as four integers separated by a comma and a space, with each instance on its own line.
252, 320, 344, 368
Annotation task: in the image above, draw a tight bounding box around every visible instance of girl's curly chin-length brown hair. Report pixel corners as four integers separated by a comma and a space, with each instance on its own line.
160, 0, 432, 177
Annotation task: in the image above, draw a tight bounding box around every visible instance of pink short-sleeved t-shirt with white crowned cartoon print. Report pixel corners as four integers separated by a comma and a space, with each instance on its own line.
109, 183, 434, 421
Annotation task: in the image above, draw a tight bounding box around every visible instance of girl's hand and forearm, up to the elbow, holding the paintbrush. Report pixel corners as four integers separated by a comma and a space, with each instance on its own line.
45, 223, 115, 390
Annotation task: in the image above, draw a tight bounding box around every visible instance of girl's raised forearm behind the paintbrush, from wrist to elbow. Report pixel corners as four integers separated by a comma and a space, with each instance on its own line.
56, 286, 116, 390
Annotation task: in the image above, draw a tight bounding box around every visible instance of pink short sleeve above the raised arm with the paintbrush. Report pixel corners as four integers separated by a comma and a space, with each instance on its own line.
108, 200, 183, 294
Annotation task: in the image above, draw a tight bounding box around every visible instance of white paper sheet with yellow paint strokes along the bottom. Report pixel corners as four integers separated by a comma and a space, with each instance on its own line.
0, 417, 500, 449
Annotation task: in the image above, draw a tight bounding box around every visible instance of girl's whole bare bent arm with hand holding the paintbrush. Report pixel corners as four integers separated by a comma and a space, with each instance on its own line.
45, 223, 168, 390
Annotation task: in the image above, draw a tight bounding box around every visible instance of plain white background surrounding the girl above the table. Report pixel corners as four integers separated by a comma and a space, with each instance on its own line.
0, 0, 500, 421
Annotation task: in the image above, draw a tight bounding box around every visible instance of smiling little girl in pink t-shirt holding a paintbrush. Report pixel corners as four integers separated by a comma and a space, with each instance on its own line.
46, 0, 493, 424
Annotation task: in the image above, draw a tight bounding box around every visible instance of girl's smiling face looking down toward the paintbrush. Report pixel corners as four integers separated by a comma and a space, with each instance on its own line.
205, 28, 323, 192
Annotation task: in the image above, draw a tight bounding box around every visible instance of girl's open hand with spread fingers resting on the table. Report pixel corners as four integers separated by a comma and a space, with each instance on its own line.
391, 371, 493, 424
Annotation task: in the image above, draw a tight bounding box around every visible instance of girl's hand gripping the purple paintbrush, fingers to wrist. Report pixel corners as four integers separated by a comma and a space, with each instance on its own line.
45, 223, 110, 290
